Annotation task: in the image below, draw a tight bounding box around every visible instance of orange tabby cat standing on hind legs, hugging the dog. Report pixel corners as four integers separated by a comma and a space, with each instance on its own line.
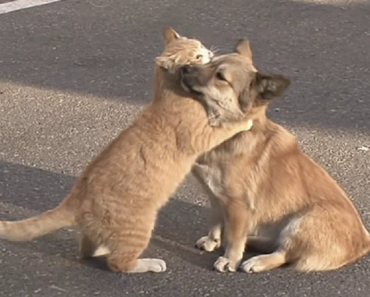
0, 29, 251, 273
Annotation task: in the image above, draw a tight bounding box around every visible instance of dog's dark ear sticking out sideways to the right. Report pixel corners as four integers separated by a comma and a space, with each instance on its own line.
255, 72, 290, 100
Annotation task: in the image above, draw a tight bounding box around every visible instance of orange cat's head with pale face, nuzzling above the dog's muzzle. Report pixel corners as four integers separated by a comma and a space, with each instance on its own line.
155, 28, 214, 71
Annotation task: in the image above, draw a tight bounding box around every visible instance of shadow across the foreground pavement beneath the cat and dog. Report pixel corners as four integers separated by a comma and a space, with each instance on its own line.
0, 158, 370, 297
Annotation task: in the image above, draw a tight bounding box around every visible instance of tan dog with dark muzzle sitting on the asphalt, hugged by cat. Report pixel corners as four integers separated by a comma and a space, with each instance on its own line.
183, 41, 370, 272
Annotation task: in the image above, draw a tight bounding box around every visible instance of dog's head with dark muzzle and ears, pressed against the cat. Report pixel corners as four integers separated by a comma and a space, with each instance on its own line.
181, 40, 290, 121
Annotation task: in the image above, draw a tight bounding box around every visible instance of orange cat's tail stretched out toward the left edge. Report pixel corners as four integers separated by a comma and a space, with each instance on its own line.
0, 196, 76, 241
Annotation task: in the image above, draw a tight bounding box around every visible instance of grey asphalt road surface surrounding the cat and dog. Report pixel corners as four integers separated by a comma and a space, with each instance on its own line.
0, 0, 370, 297
